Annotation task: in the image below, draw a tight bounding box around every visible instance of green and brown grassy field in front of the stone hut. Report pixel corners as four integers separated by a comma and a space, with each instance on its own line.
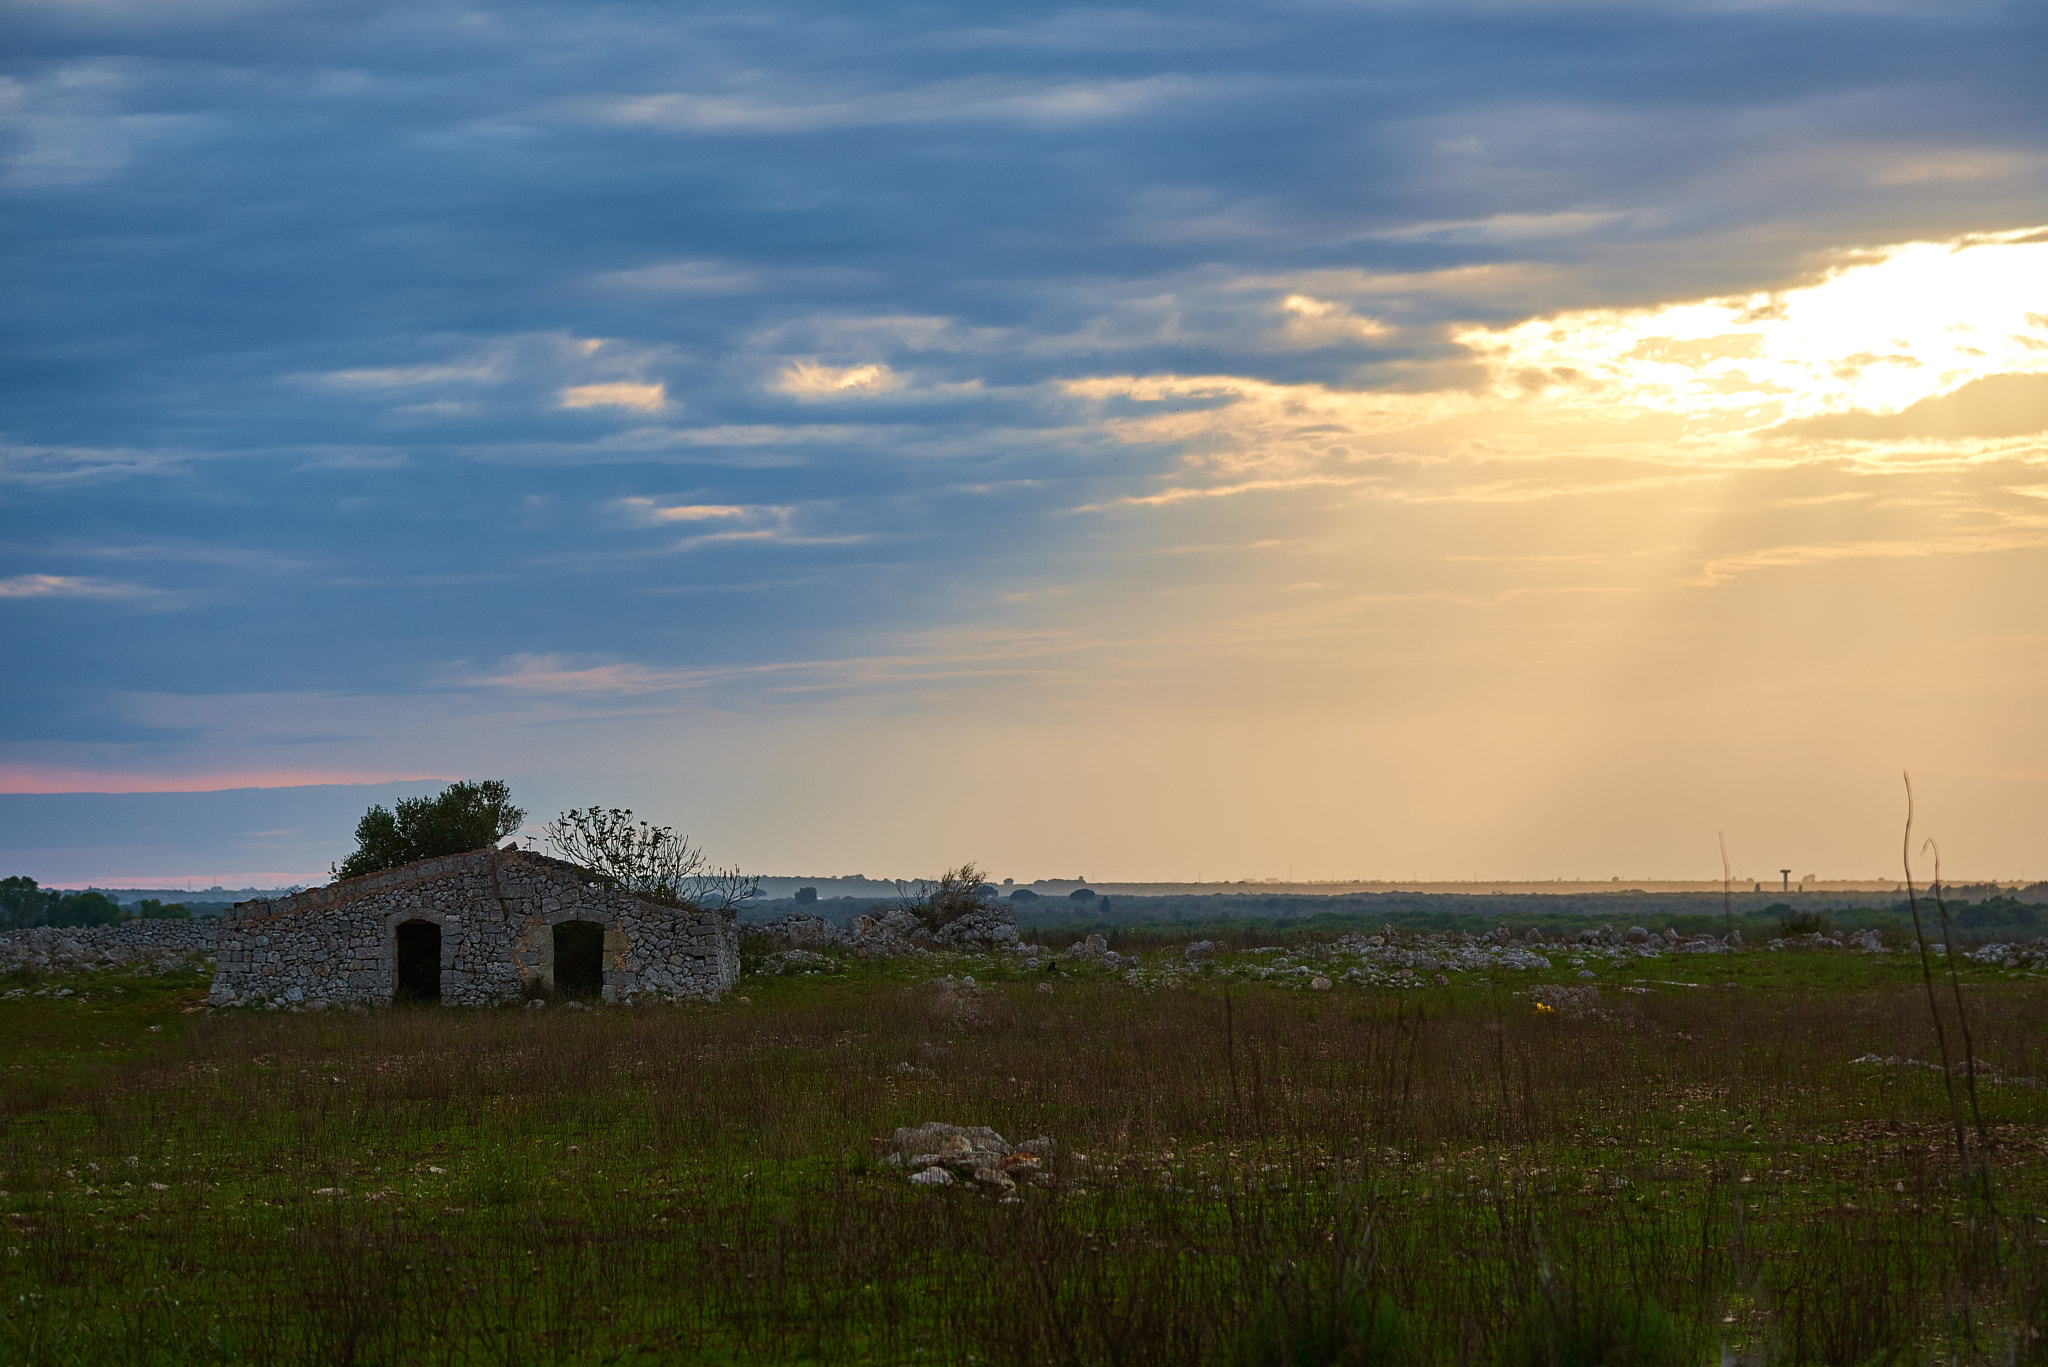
0, 943, 2048, 1365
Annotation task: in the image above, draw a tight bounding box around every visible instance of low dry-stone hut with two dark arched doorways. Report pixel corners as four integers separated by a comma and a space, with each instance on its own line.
209, 846, 739, 1006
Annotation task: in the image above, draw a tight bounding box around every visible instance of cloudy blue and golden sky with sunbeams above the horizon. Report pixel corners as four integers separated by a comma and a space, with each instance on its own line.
0, 0, 2048, 881
